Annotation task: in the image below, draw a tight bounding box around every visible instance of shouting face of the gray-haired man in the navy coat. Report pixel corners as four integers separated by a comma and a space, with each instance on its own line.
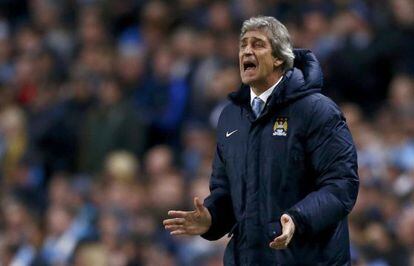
239, 30, 282, 88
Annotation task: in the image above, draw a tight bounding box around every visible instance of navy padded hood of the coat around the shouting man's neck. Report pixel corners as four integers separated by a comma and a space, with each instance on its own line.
229, 49, 323, 105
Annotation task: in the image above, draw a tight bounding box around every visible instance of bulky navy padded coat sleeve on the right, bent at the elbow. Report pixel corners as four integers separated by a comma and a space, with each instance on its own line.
287, 98, 359, 235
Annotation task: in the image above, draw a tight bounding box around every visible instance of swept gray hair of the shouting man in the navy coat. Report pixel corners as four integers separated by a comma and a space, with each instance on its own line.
240, 16, 295, 72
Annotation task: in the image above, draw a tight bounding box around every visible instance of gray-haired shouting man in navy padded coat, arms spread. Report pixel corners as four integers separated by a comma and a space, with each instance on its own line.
164, 17, 359, 265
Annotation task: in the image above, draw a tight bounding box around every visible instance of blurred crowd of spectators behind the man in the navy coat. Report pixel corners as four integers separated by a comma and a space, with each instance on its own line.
0, 0, 414, 266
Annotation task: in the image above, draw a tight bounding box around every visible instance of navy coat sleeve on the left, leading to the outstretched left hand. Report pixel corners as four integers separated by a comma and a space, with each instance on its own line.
201, 141, 236, 240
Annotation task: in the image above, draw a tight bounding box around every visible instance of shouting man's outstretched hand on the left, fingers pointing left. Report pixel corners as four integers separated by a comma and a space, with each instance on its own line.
163, 197, 211, 235
